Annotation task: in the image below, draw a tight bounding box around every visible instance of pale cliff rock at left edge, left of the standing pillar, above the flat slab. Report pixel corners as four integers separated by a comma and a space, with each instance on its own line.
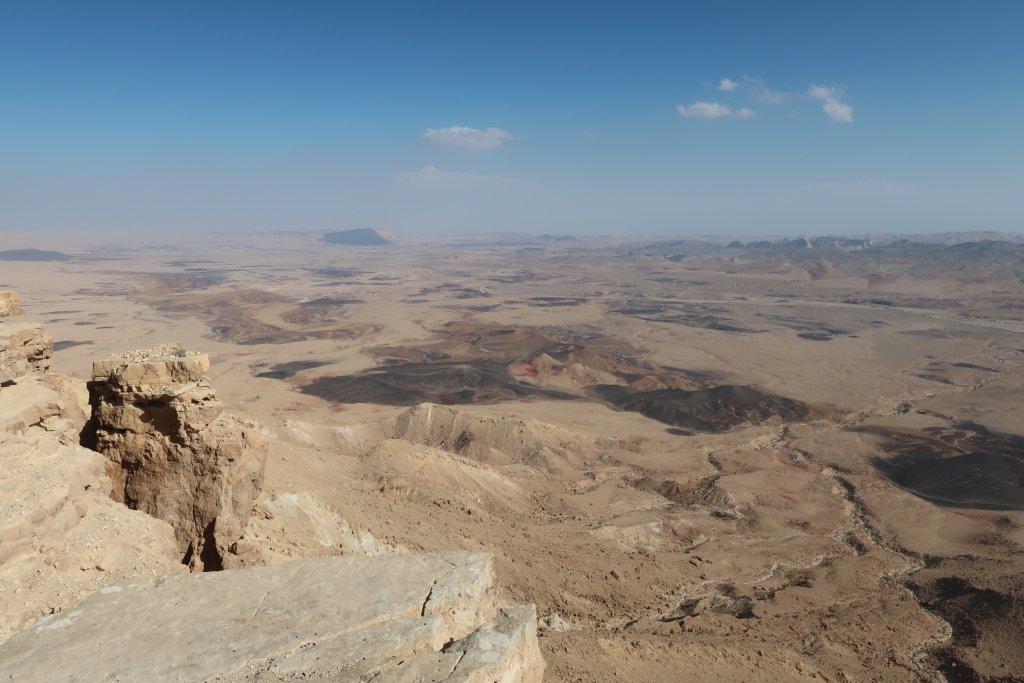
0, 292, 182, 643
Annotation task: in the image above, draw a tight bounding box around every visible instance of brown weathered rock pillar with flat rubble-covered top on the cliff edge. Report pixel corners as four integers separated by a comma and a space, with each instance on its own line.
82, 344, 266, 570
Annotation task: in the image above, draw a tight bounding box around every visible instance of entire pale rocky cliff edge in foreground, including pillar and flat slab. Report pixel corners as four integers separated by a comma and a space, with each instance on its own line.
0, 293, 545, 683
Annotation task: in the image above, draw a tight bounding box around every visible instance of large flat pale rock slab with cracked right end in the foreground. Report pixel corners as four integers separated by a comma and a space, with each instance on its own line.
0, 552, 544, 683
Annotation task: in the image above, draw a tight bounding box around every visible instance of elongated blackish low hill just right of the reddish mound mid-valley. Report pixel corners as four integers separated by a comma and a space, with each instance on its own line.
588, 384, 810, 432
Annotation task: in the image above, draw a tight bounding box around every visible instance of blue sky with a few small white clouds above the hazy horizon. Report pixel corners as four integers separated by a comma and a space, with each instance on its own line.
0, 0, 1024, 234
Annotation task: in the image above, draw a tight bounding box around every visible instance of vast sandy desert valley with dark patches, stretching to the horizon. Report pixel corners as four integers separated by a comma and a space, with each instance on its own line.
0, 233, 1024, 682
